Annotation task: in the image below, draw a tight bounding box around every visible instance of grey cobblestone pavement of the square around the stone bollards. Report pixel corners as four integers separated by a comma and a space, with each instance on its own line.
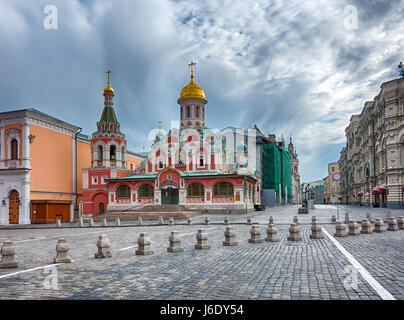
0, 206, 404, 300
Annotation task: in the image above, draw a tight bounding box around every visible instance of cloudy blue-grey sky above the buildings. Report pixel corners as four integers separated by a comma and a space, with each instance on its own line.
0, 0, 404, 182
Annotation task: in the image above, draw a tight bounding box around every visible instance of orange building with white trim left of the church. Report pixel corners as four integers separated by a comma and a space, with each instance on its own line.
0, 105, 143, 224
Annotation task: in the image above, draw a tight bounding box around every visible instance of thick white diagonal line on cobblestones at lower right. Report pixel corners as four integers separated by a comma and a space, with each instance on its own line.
321, 227, 396, 300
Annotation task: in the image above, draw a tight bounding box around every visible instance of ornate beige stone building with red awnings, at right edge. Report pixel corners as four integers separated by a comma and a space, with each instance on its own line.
338, 78, 404, 208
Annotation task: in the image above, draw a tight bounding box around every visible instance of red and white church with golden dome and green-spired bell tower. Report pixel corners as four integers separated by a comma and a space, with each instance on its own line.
79, 62, 260, 216
